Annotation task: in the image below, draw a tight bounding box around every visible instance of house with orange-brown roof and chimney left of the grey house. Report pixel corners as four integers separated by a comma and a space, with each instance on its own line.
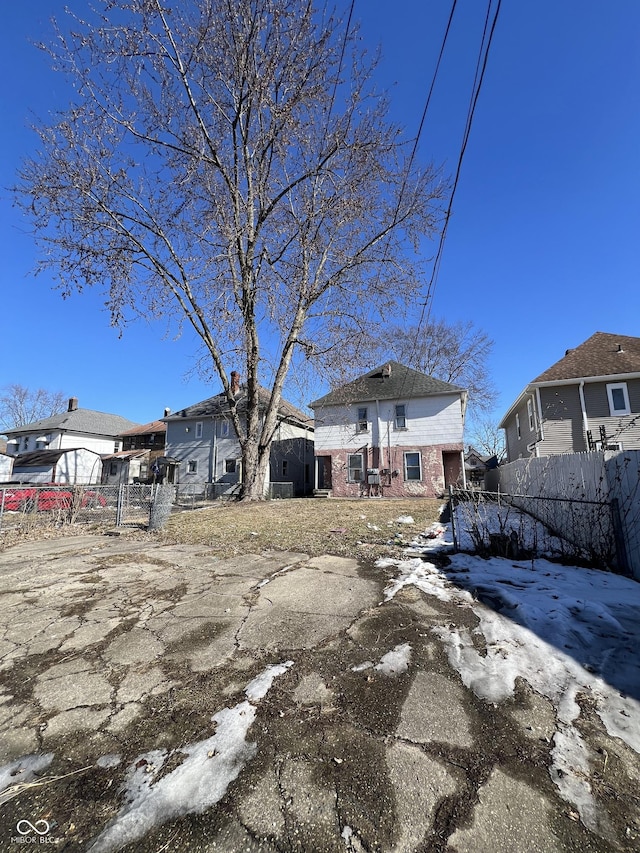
102, 416, 169, 484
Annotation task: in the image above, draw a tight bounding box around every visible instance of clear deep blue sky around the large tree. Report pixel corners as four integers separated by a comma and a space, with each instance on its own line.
0, 0, 640, 422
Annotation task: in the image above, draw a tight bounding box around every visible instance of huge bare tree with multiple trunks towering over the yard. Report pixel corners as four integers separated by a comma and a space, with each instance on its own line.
17, 0, 445, 498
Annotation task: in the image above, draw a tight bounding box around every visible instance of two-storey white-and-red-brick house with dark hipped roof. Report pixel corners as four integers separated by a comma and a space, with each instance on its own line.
310, 361, 467, 497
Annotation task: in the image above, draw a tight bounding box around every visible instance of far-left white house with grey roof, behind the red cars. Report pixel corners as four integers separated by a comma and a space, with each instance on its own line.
5, 397, 140, 483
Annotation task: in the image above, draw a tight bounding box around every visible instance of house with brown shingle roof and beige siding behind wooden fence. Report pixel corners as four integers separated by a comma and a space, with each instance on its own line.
500, 332, 640, 462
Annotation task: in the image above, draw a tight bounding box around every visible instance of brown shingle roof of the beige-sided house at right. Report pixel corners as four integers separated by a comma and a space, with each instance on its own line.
531, 332, 640, 384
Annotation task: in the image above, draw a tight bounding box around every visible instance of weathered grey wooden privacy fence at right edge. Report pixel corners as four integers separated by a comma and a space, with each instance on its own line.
499, 450, 640, 580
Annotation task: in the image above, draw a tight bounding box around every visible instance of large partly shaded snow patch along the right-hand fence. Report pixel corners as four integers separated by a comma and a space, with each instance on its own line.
379, 512, 640, 829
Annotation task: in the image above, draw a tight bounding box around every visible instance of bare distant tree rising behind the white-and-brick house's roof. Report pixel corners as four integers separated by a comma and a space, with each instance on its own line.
377, 320, 497, 413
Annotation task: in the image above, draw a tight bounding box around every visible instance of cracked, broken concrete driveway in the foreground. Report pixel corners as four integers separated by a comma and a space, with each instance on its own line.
0, 536, 637, 853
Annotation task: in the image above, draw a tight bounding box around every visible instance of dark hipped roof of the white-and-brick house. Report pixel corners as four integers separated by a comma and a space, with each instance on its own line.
309, 361, 466, 409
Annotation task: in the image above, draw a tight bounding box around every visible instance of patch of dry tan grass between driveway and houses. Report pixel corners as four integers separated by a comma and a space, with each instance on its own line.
162, 498, 442, 557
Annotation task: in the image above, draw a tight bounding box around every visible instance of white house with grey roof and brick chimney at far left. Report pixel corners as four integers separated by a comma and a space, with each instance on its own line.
6, 397, 140, 483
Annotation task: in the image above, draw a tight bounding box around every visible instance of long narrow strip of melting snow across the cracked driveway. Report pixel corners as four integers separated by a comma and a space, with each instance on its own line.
89, 661, 293, 853
